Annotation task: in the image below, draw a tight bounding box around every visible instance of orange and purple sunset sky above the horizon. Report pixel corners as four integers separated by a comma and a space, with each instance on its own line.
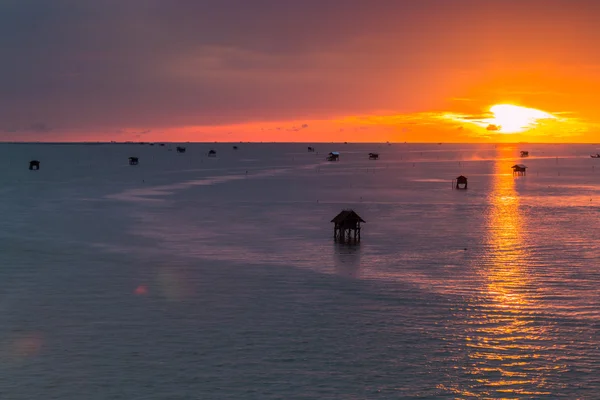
0, 0, 600, 143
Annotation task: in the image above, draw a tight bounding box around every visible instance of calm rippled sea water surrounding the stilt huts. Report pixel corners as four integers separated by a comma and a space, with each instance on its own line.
0, 144, 600, 400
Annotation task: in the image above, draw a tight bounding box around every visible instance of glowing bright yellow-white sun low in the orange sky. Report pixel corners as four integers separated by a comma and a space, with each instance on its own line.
483, 104, 557, 133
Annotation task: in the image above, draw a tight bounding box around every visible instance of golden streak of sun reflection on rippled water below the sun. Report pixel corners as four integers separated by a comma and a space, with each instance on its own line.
463, 148, 557, 398
